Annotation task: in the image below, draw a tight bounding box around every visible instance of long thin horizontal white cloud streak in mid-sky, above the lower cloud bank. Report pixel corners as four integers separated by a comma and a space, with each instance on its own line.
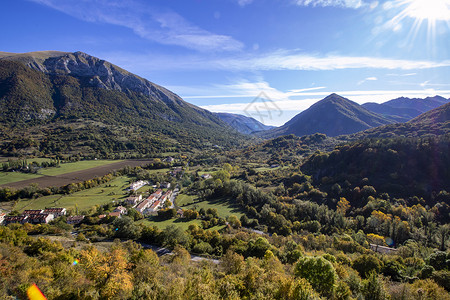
104, 50, 450, 71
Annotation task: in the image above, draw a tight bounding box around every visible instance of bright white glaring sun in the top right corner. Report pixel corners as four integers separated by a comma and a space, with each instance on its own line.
399, 0, 450, 23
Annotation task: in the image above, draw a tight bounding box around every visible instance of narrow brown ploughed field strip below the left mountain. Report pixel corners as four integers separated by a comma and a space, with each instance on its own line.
1, 160, 152, 189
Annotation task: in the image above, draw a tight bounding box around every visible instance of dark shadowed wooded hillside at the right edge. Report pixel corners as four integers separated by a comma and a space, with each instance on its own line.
301, 136, 450, 206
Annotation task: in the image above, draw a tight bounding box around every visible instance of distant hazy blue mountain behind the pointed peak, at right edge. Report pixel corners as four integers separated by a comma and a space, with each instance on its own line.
362, 96, 449, 122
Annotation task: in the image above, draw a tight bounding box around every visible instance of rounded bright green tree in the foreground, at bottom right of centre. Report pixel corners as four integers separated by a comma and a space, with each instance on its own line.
294, 257, 337, 297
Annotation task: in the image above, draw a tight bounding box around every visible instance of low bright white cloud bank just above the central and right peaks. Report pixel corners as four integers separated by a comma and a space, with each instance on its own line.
179, 77, 450, 126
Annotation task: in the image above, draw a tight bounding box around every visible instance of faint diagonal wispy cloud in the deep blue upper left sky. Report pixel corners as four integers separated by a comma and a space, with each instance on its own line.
30, 0, 244, 51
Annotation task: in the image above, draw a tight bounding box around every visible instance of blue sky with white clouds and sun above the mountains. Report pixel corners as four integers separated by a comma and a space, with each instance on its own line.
0, 0, 450, 126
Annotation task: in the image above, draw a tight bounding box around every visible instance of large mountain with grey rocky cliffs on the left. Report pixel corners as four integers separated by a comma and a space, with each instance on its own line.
0, 51, 241, 154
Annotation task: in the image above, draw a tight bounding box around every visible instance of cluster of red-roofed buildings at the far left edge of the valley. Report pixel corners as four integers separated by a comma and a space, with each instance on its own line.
0, 208, 66, 225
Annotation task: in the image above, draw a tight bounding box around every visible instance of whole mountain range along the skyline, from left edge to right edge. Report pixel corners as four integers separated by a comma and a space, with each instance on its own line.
0, 51, 449, 157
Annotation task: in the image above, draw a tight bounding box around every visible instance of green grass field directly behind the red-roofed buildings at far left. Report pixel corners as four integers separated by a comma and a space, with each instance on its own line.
14, 176, 130, 212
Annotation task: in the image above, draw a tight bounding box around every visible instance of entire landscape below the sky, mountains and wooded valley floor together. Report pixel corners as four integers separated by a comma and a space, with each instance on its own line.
0, 51, 450, 300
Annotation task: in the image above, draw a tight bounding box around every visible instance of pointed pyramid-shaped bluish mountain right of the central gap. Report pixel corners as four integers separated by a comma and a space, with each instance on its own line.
262, 94, 392, 137
